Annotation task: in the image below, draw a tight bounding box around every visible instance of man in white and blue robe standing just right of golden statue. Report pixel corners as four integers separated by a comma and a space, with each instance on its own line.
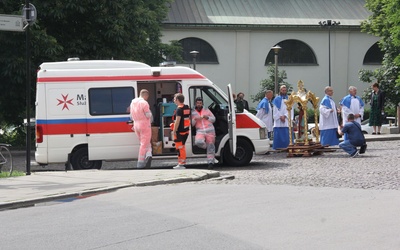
319, 87, 339, 146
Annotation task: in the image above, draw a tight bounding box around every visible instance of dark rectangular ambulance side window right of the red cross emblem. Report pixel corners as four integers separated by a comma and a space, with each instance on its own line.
89, 87, 134, 115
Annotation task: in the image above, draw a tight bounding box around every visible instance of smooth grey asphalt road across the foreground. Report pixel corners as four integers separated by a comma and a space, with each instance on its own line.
0, 183, 400, 250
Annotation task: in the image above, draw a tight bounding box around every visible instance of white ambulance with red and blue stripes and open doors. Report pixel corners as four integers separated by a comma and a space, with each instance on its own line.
35, 60, 269, 169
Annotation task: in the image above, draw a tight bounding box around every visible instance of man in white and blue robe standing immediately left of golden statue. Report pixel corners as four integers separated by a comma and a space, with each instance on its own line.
272, 85, 294, 149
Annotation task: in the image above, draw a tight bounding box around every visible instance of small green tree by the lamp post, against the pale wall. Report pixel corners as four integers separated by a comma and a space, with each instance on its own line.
250, 64, 292, 102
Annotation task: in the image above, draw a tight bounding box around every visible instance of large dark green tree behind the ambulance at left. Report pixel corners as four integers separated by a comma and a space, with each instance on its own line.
0, 0, 181, 127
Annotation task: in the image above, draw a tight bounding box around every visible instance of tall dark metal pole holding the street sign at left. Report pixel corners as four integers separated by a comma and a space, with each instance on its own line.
25, 0, 31, 175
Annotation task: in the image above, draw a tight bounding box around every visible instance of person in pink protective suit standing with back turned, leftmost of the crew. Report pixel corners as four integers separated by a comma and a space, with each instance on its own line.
130, 89, 153, 168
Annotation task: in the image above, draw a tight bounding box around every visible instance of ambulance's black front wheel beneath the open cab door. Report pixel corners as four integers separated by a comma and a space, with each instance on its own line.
224, 138, 253, 166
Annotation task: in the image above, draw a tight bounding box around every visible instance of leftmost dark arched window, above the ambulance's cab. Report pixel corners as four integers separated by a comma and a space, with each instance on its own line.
179, 37, 218, 64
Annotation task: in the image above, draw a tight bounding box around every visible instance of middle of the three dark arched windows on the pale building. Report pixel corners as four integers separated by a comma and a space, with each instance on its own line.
265, 39, 317, 66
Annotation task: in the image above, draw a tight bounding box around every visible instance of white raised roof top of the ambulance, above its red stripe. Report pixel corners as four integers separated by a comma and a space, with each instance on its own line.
40, 60, 151, 69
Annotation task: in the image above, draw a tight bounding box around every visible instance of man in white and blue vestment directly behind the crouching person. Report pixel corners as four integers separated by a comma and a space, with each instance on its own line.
340, 86, 364, 126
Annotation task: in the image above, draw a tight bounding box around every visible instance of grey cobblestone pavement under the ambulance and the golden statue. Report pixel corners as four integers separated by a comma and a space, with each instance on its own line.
11, 141, 400, 190
